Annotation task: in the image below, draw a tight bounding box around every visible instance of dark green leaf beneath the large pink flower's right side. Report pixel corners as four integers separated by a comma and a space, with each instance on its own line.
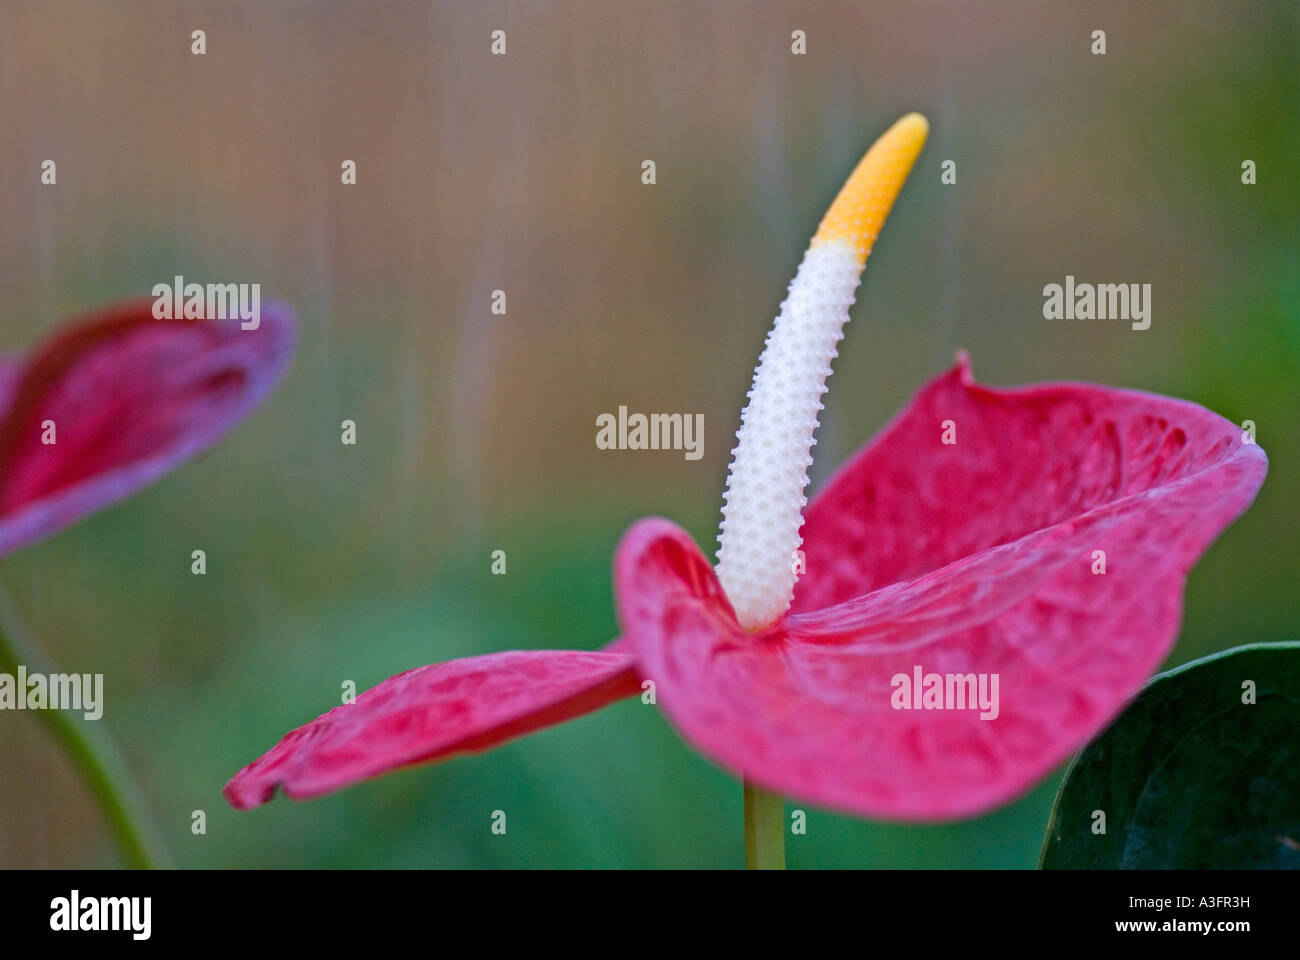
1041, 643, 1300, 869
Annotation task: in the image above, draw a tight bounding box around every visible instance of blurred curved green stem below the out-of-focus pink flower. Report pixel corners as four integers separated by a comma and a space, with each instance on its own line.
0, 597, 166, 870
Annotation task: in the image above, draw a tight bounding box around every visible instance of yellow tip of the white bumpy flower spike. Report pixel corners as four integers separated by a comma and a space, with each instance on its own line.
813, 113, 930, 267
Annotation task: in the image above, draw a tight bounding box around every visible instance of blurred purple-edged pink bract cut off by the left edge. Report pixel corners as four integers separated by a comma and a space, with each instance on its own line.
0, 299, 294, 557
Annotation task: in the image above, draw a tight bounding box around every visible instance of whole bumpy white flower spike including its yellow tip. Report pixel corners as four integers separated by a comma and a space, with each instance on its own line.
718, 113, 930, 628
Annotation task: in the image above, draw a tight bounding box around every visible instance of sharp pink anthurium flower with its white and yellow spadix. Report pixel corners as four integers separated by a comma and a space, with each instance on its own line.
225, 114, 1266, 821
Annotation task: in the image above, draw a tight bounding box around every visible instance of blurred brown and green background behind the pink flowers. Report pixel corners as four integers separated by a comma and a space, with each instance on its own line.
0, 0, 1300, 868
